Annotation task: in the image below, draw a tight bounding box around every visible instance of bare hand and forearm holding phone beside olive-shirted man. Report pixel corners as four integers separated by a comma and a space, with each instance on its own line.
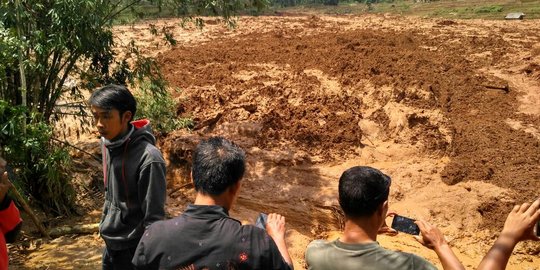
416, 220, 465, 270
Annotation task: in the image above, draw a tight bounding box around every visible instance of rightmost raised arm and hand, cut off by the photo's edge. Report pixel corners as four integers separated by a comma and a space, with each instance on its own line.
478, 199, 540, 270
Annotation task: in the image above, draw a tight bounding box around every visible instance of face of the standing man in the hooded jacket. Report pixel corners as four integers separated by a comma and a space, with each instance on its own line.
91, 105, 131, 140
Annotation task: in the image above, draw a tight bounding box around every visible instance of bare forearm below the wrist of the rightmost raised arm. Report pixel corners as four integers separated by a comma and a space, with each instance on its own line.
477, 234, 517, 270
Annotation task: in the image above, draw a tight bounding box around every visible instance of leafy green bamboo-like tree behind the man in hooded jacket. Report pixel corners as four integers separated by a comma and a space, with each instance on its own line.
0, 0, 265, 214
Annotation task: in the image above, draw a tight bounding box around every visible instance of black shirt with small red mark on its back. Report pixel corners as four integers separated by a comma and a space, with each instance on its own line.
133, 205, 290, 270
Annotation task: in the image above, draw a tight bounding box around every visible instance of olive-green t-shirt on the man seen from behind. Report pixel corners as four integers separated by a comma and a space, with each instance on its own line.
306, 240, 437, 270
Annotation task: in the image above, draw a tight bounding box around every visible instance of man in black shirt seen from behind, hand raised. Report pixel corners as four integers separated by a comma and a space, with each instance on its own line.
133, 137, 292, 269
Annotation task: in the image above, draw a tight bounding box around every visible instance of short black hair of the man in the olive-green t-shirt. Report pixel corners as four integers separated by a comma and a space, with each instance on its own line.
339, 166, 391, 217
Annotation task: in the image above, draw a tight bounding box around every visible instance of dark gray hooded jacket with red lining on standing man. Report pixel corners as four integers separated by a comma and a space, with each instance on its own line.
99, 120, 166, 250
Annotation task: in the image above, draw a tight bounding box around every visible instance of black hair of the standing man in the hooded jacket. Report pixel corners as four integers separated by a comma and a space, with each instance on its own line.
89, 84, 137, 120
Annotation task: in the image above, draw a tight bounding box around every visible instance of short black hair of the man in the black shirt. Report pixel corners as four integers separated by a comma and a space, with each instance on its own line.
191, 137, 246, 195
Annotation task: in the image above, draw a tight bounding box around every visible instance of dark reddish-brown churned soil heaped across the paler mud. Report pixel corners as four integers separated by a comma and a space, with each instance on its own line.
160, 17, 540, 228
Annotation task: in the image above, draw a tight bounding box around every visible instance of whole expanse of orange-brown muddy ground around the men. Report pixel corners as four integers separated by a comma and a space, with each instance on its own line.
8, 14, 540, 269
